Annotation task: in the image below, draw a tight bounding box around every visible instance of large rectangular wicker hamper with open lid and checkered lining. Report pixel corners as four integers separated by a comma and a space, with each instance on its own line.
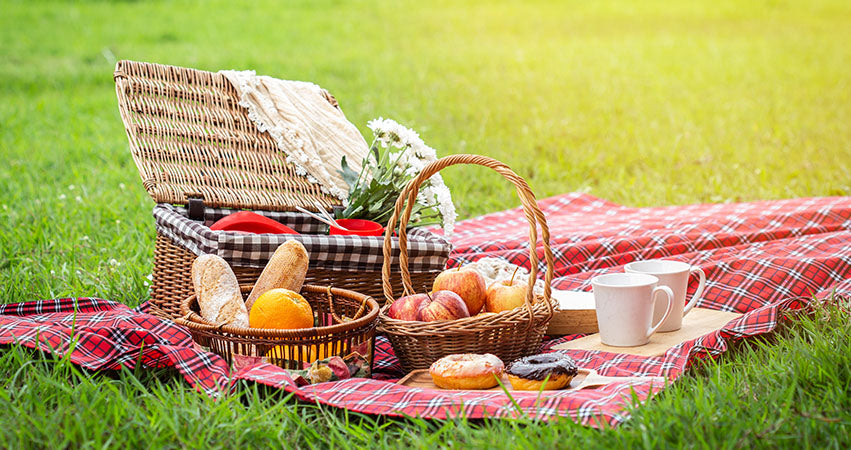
114, 61, 450, 318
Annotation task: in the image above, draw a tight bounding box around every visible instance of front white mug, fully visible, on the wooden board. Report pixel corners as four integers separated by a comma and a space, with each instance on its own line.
591, 273, 674, 347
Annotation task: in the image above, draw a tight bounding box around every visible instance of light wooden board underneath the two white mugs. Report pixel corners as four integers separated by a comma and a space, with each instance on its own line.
553, 308, 742, 356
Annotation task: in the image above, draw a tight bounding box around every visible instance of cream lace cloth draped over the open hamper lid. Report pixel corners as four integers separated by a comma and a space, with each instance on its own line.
220, 70, 369, 200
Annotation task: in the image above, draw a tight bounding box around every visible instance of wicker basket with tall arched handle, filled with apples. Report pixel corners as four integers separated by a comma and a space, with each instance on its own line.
378, 155, 553, 371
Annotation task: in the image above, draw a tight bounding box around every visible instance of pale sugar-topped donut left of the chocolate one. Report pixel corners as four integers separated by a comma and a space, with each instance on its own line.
428, 353, 505, 389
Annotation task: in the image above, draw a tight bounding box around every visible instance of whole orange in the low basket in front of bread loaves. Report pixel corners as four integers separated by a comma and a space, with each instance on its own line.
248, 289, 313, 330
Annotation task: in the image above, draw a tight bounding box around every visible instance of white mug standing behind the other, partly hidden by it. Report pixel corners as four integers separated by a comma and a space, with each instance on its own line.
624, 259, 706, 332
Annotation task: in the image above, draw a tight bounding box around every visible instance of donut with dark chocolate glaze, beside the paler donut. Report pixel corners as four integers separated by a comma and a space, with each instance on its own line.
505, 352, 579, 391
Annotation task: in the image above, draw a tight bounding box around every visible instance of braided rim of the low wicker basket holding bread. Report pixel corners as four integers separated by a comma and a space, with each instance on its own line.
175, 284, 379, 339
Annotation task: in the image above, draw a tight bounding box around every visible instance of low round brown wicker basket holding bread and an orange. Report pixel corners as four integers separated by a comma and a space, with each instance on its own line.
175, 285, 379, 370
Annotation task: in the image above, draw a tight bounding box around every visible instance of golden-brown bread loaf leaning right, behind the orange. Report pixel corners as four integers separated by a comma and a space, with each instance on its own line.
245, 239, 308, 311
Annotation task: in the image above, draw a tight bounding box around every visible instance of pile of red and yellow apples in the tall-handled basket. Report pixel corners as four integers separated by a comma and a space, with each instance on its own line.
387, 267, 526, 322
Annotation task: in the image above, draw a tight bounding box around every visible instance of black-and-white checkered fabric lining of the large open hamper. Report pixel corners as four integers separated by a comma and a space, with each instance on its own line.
154, 204, 452, 272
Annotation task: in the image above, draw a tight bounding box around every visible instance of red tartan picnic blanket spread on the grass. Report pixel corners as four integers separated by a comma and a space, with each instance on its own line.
0, 193, 851, 427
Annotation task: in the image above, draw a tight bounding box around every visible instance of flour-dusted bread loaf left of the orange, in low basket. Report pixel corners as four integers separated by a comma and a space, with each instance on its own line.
192, 255, 248, 327
